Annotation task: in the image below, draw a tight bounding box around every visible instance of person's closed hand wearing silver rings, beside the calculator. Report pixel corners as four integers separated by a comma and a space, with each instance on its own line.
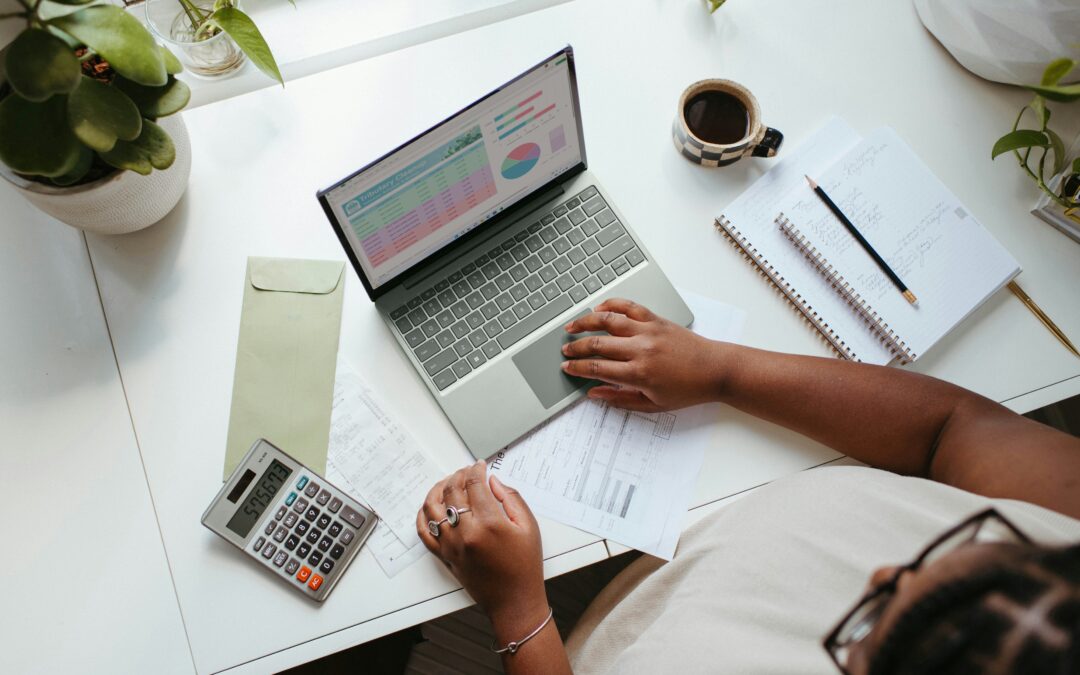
416, 460, 548, 635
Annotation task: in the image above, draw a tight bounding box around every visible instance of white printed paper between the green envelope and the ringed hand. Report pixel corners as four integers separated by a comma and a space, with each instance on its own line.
326, 361, 444, 577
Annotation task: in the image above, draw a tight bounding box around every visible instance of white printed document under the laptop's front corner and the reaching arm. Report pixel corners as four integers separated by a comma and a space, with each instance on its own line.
489, 292, 745, 561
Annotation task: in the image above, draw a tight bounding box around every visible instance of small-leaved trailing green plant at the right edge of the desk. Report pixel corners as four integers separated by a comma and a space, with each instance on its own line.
990, 58, 1080, 210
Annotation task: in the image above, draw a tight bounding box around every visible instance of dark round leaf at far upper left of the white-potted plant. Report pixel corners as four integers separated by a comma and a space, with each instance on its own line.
4, 28, 82, 100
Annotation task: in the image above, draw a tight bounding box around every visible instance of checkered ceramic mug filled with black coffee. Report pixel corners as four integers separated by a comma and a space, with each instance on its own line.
672, 80, 784, 166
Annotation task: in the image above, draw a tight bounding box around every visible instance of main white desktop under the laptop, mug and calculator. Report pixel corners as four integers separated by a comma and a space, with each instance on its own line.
10, 0, 1080, 672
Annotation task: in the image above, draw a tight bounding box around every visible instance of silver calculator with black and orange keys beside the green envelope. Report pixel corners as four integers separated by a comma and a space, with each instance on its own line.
202, 438, 378, 603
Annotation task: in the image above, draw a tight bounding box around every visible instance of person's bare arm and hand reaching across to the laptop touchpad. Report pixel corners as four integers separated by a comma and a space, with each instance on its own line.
564, 299, 1080, 517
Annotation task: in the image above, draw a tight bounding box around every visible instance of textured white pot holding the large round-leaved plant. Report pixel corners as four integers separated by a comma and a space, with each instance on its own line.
0, 113, 191, 234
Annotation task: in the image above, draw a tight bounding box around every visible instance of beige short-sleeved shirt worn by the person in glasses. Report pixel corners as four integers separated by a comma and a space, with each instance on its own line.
567, 467, 1080, 675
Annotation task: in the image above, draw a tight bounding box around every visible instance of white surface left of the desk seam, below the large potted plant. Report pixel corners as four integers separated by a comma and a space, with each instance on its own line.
0, 185, 193, 673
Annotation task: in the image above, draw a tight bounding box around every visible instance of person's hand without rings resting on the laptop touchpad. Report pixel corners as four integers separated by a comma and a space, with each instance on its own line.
563, 298, 721, 413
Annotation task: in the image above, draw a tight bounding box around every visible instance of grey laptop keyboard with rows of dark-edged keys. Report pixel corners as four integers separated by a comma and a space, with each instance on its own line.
390, 187, 645, 390
